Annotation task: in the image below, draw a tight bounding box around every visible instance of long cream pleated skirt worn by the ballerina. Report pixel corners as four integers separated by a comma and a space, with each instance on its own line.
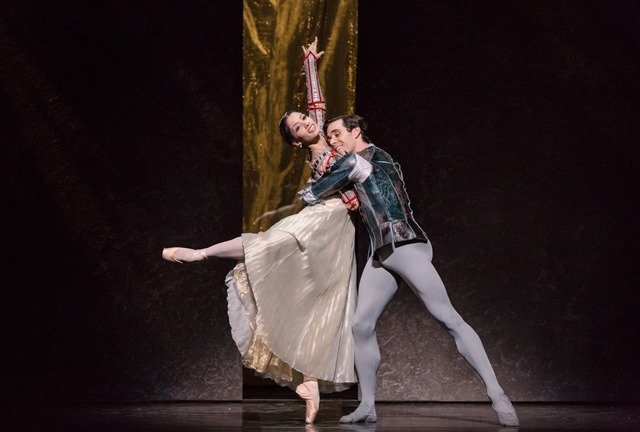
226, 198, 356, 392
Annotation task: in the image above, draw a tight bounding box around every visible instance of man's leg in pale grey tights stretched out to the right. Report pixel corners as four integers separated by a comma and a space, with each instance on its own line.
383, 243, 518, 426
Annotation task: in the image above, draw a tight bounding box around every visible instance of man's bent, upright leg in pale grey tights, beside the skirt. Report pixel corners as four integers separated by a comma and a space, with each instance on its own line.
340, 253, 398, 423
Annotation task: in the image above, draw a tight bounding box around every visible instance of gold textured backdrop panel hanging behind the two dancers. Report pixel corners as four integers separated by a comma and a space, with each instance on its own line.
242, 0, 358, 232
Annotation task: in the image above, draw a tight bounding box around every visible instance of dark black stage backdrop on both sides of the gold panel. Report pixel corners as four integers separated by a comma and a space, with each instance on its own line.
0, 0, 640, 401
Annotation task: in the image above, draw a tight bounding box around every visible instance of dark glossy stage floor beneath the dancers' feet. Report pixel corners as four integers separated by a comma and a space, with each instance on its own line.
0, 400, 640, 432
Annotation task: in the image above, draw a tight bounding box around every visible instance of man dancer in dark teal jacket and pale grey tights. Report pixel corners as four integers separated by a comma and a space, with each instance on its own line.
300, 115, 519, 426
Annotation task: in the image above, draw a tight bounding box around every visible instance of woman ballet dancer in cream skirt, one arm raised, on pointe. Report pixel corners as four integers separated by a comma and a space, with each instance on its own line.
162, 38, 358, 423
